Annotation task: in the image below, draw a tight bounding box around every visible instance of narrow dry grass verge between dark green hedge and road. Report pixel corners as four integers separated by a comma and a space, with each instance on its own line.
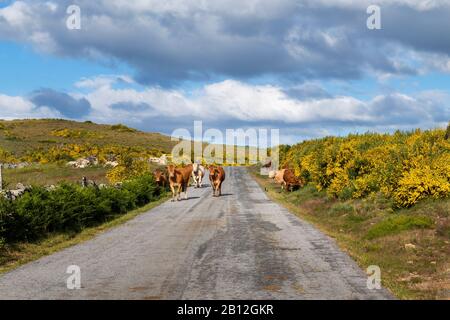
0, 193, 169, 274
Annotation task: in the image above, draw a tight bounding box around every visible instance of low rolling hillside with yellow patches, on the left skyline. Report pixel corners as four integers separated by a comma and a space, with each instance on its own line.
0, 119, 175, 161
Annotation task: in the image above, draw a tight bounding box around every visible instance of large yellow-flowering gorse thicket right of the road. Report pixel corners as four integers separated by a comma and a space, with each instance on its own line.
282, 129, 450, 207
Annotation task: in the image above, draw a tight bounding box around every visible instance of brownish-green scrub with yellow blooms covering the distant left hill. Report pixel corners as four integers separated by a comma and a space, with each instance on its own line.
0, 119, 176, 163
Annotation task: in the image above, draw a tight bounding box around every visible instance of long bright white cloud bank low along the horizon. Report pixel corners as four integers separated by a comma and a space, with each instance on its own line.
0, 76, 450, 142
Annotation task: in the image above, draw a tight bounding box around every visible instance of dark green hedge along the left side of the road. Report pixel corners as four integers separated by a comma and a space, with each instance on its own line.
0, 174, 161, 243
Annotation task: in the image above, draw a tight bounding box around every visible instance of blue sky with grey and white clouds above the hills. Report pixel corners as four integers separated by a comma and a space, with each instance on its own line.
0, 0, 450, 143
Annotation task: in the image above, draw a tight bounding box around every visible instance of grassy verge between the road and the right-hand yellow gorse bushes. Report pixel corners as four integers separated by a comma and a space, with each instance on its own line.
249, 168, 450, 299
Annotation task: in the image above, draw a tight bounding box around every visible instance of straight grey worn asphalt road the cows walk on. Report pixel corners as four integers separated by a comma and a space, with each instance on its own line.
0, 168, 391, 299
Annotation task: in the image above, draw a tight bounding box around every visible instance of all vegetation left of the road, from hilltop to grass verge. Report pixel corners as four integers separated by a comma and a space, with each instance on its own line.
0, 120, 174, 272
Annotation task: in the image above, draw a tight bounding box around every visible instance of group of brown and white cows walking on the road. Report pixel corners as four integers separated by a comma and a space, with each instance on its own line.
153, 163, 225, 201
